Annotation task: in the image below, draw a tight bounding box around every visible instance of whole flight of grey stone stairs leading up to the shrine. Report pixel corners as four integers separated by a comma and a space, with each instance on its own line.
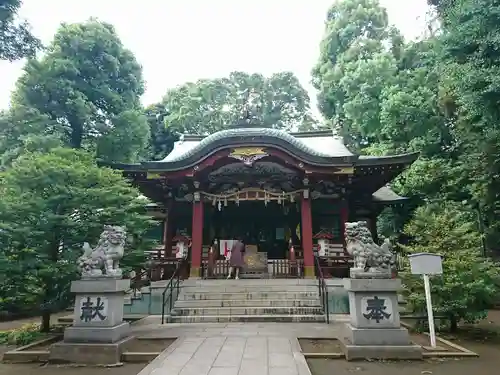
169, 279, 325, 323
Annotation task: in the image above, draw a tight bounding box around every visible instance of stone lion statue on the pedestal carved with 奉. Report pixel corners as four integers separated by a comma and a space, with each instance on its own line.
345, 221, 394, 277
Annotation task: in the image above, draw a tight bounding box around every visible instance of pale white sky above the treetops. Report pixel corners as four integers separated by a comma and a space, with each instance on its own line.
0, 0, 427, 109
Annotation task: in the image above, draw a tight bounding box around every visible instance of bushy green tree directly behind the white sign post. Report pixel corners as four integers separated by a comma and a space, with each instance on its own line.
402, 203, 500, 330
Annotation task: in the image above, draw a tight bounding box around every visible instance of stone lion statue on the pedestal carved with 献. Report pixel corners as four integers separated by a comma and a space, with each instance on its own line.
78, 225, 127, 278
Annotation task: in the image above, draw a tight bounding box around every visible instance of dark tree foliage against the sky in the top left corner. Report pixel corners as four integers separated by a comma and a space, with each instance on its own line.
0, 0, 42, 61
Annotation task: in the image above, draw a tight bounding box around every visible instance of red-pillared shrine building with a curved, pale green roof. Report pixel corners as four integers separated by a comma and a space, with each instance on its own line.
106, 123, 418, 277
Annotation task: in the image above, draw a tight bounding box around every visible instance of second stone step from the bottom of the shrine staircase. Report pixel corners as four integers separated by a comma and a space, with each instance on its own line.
172, 306, 324, 316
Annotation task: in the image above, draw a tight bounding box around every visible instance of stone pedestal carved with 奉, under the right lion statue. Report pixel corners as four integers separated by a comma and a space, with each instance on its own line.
341, 279, 422, 360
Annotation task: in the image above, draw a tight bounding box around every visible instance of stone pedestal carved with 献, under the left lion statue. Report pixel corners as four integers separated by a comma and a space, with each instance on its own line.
50, 277, 131, 364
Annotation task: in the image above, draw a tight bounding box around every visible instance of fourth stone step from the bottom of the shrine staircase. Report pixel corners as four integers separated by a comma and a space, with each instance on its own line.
178, 290, 319, 301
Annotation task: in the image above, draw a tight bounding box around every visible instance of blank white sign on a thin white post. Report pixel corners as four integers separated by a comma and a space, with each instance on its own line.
408, 253, 443, 348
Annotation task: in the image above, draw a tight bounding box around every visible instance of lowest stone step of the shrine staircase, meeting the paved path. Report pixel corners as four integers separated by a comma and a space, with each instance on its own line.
170, 314, 325, 323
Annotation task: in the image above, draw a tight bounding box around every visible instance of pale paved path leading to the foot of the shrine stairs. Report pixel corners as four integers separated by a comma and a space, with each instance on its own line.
136, 323, 338, 375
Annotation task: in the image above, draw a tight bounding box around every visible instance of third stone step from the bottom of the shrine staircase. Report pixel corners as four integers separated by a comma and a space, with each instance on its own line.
175, 298, 321, 309
